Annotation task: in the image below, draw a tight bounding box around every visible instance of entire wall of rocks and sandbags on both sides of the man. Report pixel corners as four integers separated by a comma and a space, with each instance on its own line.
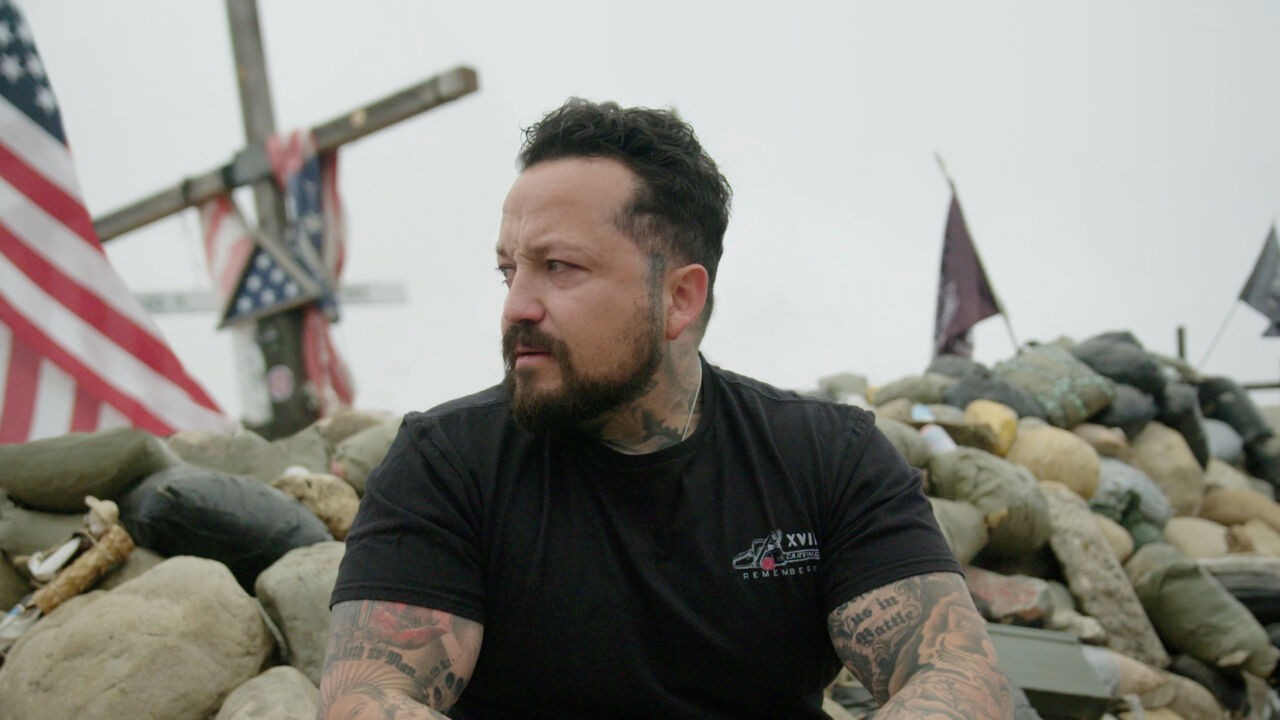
0, 333, 1280, 720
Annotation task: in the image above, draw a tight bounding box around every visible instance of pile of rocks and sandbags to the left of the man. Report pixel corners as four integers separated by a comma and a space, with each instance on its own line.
0, 411, 399, 720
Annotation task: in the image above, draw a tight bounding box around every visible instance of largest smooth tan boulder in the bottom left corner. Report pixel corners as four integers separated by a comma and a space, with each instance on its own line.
0, 557, 273, 720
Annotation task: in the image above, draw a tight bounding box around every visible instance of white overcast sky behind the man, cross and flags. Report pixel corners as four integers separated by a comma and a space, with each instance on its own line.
19, 0, 1280, 414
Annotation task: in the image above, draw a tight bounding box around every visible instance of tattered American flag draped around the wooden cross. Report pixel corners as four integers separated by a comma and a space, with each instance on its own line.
201, 132, 355, 416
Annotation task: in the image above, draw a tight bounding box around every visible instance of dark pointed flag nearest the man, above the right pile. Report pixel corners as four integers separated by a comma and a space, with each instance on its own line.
933, 192, 1001, 357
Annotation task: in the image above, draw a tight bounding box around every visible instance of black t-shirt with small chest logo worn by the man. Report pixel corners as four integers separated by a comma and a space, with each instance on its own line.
333, 364, 959, 720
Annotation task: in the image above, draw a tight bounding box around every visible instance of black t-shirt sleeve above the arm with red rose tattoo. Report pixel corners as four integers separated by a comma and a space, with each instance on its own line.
330, 415, 484, 623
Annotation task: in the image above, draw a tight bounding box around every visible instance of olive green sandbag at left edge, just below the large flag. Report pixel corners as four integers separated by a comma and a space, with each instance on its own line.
0, 428, 178, 512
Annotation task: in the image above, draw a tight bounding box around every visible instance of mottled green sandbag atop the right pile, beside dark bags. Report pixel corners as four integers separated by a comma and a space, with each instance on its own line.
995, 345, 1115, 429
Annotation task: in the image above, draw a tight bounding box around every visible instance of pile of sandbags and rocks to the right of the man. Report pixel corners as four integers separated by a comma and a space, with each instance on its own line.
820, 332, 1280, 720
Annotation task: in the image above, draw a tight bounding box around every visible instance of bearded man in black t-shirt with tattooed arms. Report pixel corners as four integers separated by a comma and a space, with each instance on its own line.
320, 100, 1011, 719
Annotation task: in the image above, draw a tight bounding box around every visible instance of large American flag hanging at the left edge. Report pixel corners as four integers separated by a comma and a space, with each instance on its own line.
0, 0, 230, 443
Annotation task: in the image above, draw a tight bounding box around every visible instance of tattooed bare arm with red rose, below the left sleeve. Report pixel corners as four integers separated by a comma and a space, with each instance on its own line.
316, 600, 484, 720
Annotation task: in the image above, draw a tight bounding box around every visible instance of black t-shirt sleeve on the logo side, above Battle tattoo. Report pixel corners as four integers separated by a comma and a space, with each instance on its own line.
822, 411, 960, 612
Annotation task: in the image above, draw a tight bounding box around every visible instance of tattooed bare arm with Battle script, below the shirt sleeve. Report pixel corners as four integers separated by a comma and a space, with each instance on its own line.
827, 573, 1012, 720
